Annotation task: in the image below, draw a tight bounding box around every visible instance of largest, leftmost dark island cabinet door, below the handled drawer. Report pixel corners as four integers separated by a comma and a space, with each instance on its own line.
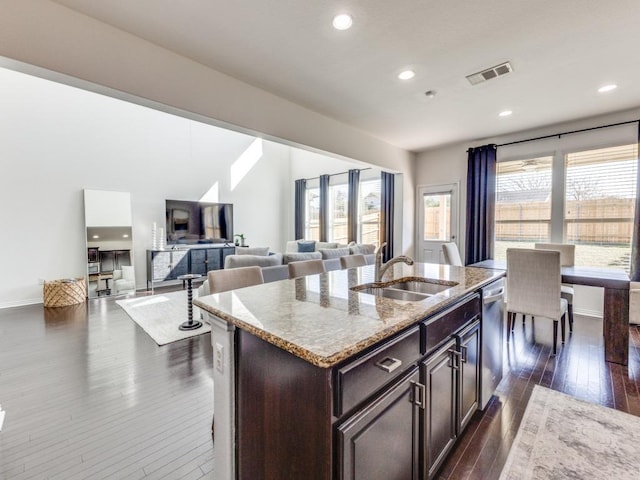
338, 366, 422, 480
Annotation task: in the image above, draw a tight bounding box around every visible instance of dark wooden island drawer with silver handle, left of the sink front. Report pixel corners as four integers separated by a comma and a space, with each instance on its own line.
335, 326, 420, 417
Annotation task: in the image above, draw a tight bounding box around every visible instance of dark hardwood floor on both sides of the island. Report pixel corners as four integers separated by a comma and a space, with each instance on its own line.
0, 292, 640, 480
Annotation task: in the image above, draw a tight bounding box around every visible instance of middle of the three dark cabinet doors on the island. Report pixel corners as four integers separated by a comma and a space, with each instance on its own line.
422, 339, 458, 478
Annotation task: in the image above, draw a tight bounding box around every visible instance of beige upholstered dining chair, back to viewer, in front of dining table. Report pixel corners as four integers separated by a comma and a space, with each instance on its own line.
507, 248, 567, 355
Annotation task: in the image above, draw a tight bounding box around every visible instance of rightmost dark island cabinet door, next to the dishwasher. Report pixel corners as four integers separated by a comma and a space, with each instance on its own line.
458, 320, 480, 433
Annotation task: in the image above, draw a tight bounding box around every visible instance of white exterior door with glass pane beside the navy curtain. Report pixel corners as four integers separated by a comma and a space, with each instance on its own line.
416, 183, 458, 263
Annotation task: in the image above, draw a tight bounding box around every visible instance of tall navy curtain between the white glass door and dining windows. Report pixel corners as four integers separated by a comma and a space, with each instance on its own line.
465, 144, 497, 265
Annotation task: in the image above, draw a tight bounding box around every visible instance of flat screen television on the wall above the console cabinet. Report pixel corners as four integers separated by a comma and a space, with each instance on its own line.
165, 200, 233, 245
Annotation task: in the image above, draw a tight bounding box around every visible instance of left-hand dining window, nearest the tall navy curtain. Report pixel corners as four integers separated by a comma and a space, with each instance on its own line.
494, 157, 553, 260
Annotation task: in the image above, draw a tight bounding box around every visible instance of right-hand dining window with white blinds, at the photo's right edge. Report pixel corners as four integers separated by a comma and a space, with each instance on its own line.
564, 143, 637, 271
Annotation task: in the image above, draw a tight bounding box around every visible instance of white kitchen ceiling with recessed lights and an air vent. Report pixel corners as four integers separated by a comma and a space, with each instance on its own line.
54, 0, 640, 151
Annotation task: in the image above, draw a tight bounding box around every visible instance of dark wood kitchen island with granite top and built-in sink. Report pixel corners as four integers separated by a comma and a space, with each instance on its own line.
194, 264, 504, 480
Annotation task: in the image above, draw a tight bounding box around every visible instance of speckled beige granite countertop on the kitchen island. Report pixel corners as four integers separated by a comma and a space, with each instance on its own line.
193, 263, 505, 368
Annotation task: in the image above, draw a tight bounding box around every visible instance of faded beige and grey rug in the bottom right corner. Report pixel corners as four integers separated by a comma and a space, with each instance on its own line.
500, 385, 640, 480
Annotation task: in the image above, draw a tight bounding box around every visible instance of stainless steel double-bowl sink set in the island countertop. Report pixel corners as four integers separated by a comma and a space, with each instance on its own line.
351, 277, 458, 302
